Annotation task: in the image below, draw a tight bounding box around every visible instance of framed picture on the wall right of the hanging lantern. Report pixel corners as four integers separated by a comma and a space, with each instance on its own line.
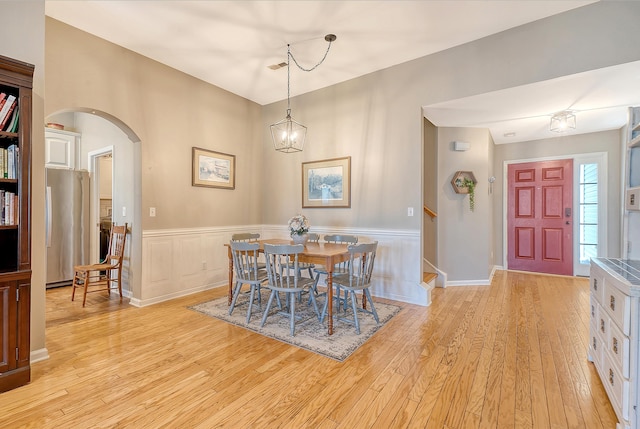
302, 156, 351, 208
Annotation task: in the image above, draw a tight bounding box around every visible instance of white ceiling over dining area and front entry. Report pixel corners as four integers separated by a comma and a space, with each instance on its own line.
45, 0, 640, 143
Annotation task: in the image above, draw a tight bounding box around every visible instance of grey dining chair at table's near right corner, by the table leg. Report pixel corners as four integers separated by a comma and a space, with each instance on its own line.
320, 241, 380, 334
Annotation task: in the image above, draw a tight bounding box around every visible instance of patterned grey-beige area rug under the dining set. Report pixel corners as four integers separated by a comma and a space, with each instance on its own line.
189, 294, 401, 362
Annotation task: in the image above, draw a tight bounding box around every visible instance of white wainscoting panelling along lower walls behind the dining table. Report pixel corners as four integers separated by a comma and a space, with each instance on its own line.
141, 225, 431, 306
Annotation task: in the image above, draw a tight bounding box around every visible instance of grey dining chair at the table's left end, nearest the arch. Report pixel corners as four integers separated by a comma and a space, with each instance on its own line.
229, 240, 267, 323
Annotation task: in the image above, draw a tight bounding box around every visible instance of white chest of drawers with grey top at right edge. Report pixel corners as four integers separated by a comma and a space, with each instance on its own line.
589, 258, 640, 429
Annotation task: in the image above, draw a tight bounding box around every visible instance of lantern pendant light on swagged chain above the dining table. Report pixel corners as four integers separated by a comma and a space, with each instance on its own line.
269, 34, 336, 153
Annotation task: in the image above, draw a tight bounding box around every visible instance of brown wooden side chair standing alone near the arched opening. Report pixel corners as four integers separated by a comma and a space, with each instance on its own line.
71, 223, 127, 307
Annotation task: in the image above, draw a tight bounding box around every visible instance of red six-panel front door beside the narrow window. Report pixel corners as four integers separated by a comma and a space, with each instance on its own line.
507, 159, 573, 275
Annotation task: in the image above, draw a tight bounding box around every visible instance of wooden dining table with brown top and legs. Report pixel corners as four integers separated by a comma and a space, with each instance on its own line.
225, 238, 349, 335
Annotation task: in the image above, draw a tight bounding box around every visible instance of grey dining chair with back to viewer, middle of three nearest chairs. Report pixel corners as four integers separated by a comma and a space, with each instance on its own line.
260, 243, 320, 336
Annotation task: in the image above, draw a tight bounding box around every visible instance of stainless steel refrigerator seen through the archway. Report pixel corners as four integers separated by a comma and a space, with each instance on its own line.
45, 168, 90, 288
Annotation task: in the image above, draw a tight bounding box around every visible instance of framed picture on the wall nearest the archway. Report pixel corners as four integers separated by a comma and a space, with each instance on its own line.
191, 147, 236, 189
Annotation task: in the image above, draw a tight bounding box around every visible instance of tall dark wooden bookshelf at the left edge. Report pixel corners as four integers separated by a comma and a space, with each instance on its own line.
0, 56, 34, 392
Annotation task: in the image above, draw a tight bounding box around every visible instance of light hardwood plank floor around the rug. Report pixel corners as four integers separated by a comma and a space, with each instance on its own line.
0, 271, 616, 429
